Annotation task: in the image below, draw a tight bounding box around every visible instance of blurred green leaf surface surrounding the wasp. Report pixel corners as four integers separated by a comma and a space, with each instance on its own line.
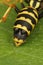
0, 1, 43, 65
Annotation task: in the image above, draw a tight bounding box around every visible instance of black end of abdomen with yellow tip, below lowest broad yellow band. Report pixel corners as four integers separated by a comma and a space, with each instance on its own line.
14, 28, 28, 46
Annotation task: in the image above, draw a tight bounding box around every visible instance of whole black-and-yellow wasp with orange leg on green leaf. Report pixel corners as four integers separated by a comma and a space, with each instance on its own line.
0, 0, 43, 46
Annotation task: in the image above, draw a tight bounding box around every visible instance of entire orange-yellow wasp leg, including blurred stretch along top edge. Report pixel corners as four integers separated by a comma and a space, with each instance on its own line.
0, 0, 23, 23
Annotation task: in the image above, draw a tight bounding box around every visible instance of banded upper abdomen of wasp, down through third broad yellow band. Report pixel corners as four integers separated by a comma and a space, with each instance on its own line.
14, 7, 38, 35
